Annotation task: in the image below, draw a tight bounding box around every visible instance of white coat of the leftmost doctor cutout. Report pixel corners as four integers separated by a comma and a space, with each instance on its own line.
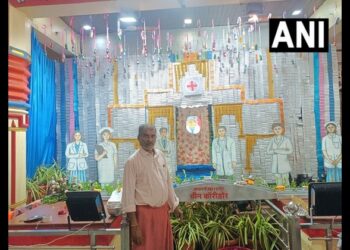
65, 141, 89, 171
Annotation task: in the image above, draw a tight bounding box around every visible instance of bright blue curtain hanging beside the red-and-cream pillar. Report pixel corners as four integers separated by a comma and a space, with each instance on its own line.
26, 29, 56, 178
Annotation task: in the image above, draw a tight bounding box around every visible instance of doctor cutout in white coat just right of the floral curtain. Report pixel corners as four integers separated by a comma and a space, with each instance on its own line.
212, 126, 237, 177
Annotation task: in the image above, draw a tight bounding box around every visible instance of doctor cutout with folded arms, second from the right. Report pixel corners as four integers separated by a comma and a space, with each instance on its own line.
267, 123, 293, 187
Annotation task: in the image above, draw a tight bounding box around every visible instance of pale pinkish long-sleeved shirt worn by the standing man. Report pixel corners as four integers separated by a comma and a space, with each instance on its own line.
122, 148, 179, 213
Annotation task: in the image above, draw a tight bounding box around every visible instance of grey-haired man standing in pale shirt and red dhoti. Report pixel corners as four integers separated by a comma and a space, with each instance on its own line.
122, 124, 182, 250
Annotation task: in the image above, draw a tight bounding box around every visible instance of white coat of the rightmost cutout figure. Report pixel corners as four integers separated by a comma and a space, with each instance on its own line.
322, 133, 342, 168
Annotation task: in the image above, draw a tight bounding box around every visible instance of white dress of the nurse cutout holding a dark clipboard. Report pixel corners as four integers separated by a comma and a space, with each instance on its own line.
95, 142, 117, 184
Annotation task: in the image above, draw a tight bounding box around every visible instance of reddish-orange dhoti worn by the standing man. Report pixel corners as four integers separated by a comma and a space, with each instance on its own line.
132, 203, 173, 250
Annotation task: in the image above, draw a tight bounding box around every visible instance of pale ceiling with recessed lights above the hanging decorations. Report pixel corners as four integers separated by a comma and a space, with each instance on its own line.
9, 0, 325, 34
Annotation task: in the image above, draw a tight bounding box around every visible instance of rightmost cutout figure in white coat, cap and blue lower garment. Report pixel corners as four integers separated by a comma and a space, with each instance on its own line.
322, 121, 342, 182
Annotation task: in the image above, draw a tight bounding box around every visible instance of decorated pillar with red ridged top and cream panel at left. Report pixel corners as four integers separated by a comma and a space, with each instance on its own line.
8, 46, 30, 208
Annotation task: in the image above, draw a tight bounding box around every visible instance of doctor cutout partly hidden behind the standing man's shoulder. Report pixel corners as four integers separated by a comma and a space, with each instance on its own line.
155, 127, 176, 177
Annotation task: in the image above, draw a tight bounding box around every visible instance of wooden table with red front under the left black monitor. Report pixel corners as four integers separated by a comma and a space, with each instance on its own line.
8, 201, 122, 249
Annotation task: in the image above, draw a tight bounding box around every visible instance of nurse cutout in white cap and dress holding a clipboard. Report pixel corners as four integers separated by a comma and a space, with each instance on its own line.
95, 127, 117, 186
